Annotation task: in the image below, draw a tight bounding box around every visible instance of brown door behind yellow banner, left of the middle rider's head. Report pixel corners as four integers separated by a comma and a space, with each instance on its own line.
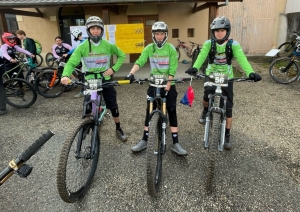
128, 15, 158, 62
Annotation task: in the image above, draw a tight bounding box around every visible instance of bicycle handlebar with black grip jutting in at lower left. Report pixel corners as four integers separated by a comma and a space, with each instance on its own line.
0, 130, 54, 185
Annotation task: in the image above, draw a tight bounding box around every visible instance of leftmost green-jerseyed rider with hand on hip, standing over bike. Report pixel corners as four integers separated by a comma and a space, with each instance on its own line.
61, 16, 128, 141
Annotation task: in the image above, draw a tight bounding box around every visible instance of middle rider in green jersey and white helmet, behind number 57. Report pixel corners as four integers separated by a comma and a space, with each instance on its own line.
125, 22, 187, 155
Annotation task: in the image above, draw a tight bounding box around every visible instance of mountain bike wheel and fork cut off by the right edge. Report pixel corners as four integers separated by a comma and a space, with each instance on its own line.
269, 36, 300, 84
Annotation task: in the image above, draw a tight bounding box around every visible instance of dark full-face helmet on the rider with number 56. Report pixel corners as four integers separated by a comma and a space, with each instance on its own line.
210, 16, 231, 43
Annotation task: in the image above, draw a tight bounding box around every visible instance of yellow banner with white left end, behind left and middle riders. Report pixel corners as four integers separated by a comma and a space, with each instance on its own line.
105, 24, 144, 54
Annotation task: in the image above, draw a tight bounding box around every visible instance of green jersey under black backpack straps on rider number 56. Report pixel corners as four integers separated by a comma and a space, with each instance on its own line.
193, 40, 254, 78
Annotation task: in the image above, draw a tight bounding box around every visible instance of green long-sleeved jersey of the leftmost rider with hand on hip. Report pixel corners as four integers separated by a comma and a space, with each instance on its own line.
63, 40, 126, 80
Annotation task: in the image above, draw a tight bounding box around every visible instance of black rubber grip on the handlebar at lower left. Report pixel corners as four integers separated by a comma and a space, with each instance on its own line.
19, 130, 54, 162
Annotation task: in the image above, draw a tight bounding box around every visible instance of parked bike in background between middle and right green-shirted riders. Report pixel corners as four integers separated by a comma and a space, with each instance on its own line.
176, 39, 208, 73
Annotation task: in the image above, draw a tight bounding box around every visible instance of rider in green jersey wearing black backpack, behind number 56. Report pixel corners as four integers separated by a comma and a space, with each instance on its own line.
185, 16, 262, 150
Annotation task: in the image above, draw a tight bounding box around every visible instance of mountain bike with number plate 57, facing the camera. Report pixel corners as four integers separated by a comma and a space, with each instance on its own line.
133, 75, 186, 197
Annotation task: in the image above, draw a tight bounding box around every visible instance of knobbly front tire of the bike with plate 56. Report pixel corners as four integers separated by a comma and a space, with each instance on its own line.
206, 100, 221, 193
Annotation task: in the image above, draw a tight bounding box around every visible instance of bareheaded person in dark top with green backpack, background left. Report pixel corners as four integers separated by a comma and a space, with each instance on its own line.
16, 30, 37, 69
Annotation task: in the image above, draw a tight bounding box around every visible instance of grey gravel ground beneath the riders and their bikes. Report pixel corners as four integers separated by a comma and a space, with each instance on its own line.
0, 58, 300, 212
